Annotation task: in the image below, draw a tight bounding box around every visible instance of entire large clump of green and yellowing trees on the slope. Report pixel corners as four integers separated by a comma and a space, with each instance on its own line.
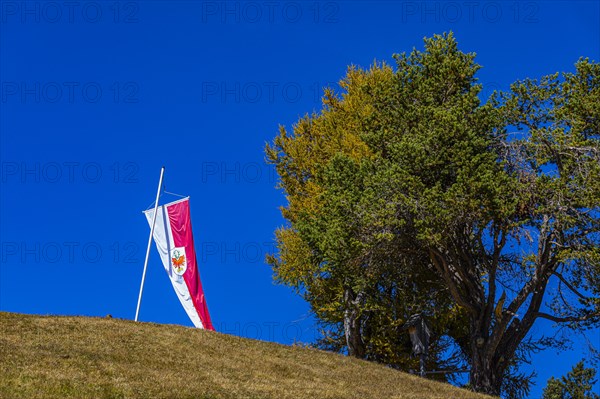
267, 34, 600, 397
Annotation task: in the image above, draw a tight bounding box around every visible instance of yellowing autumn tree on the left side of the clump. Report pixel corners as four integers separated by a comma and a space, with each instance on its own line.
267, 60, 462, 376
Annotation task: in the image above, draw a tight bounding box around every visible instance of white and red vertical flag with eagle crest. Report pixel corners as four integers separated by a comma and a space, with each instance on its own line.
144, 197, 214, 330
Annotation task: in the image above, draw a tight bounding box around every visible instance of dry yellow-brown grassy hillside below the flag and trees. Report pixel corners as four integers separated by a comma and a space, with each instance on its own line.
0, 312, 488, 399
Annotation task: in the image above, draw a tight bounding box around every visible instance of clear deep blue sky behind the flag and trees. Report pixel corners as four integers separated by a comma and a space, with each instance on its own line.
0, 0, 600, 398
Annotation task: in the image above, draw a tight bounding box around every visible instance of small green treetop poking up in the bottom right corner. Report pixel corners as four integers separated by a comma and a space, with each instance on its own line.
542, 361, 600, 399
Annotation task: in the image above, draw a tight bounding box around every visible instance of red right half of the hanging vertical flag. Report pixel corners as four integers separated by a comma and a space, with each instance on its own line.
167, 200, 215, 331
